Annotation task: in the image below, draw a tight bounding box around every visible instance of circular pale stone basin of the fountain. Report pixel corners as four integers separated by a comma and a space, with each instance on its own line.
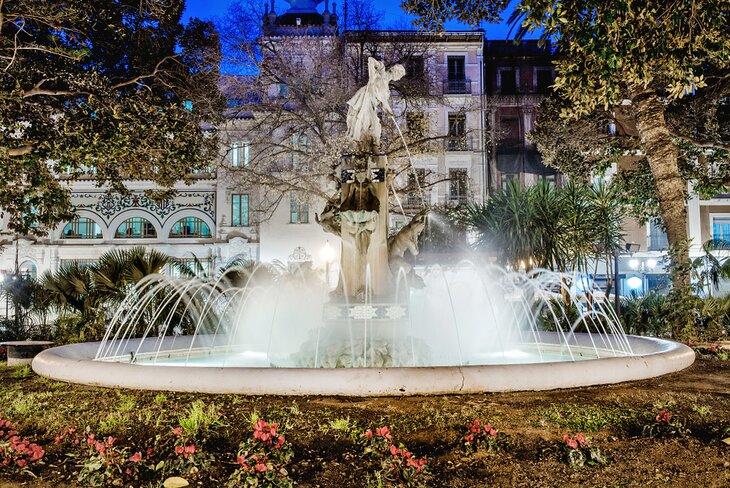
33, 334, 695, 396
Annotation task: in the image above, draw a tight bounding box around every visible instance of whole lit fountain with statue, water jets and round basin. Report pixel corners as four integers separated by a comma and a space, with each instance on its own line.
33, 58, 694, 396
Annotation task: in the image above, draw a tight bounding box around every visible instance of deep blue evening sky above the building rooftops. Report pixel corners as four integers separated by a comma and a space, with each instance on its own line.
179, 0, 528, 39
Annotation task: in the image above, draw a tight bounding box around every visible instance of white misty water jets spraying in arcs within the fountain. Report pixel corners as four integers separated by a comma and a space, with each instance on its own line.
96, 262, 631, 368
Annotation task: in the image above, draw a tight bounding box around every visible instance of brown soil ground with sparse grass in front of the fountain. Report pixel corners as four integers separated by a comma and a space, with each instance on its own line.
0, 359, 730, 488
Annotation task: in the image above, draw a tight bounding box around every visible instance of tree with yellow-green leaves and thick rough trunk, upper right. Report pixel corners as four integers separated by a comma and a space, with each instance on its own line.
403, 0, 730, 289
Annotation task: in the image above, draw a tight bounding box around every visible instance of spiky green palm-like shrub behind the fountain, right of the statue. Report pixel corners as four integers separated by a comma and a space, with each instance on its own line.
456, 181, 626, 273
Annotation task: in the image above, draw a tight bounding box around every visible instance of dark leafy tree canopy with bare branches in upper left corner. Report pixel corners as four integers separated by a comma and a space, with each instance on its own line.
0, 0, 221, 235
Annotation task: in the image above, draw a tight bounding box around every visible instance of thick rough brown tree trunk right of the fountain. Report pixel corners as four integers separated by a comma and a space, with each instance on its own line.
633, 90, 690, 290
